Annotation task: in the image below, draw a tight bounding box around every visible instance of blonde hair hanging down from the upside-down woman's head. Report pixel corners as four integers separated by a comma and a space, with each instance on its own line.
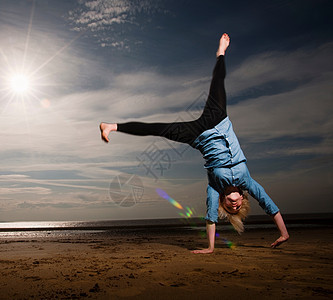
219, 192, 250, 234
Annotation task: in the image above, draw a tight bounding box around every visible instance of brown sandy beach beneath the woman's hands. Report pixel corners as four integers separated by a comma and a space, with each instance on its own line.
0, 227, 333, 300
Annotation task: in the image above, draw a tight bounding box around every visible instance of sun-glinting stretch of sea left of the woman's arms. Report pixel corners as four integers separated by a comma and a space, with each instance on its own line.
0, 218, 205, 240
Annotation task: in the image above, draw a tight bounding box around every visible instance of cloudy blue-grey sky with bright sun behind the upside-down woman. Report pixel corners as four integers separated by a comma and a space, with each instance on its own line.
0, 0, 333, 222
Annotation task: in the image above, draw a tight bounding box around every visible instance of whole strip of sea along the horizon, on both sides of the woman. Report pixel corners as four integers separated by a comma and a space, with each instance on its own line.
0, 213, 333, 240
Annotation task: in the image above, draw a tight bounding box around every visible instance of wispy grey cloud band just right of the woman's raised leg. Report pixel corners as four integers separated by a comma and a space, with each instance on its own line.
227, 43, 333, 98
